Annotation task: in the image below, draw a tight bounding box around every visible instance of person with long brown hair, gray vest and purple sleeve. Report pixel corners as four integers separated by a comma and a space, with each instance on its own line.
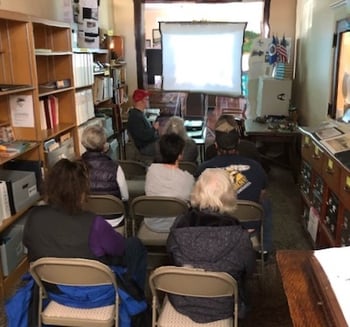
23, 159, 147, 289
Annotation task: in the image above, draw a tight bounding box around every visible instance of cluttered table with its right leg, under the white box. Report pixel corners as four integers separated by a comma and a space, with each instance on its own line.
244, 119, 301, 182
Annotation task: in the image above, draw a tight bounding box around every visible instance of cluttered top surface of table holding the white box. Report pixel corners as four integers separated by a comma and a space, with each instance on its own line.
244, 118, 300, 136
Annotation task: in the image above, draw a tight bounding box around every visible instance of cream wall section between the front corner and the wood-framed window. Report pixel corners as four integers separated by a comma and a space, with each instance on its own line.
295, 0, 349, 126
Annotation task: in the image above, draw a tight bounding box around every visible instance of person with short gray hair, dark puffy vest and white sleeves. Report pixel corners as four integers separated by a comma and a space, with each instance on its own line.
81, 125, 129, 228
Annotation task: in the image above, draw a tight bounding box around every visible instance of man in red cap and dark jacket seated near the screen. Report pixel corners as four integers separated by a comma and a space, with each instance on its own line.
127, 89, 159, 157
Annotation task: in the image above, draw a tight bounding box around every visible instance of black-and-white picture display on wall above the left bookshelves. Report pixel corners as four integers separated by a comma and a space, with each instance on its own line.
73, 0, 100, 49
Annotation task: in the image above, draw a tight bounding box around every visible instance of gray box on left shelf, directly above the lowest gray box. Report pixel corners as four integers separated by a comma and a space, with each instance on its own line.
0, 169, 40, 214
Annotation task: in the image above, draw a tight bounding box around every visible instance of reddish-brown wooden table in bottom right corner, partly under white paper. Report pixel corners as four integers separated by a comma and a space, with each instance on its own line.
276, 250, 335, 327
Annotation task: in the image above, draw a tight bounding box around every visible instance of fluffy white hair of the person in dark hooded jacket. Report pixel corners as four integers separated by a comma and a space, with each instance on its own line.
190, 168, 237, 215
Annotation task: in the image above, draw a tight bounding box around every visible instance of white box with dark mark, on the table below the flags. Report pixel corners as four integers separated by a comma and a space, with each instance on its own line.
256, 77, 292, 116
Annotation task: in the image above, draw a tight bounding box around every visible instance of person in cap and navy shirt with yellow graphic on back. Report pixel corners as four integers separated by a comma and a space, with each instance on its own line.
195, 115, 272, 256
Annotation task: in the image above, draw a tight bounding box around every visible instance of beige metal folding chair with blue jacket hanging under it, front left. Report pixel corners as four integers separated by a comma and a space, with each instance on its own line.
30, 257, 119, 327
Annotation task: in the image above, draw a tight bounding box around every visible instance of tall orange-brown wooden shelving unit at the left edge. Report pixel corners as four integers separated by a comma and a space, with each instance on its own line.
0, 10, 77, 297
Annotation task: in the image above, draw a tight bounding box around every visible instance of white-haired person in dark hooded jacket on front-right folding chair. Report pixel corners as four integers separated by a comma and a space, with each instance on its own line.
167, 168, 256, 323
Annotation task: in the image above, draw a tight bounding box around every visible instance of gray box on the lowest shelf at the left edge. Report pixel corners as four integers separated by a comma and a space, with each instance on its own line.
0, 225, 25, 276
